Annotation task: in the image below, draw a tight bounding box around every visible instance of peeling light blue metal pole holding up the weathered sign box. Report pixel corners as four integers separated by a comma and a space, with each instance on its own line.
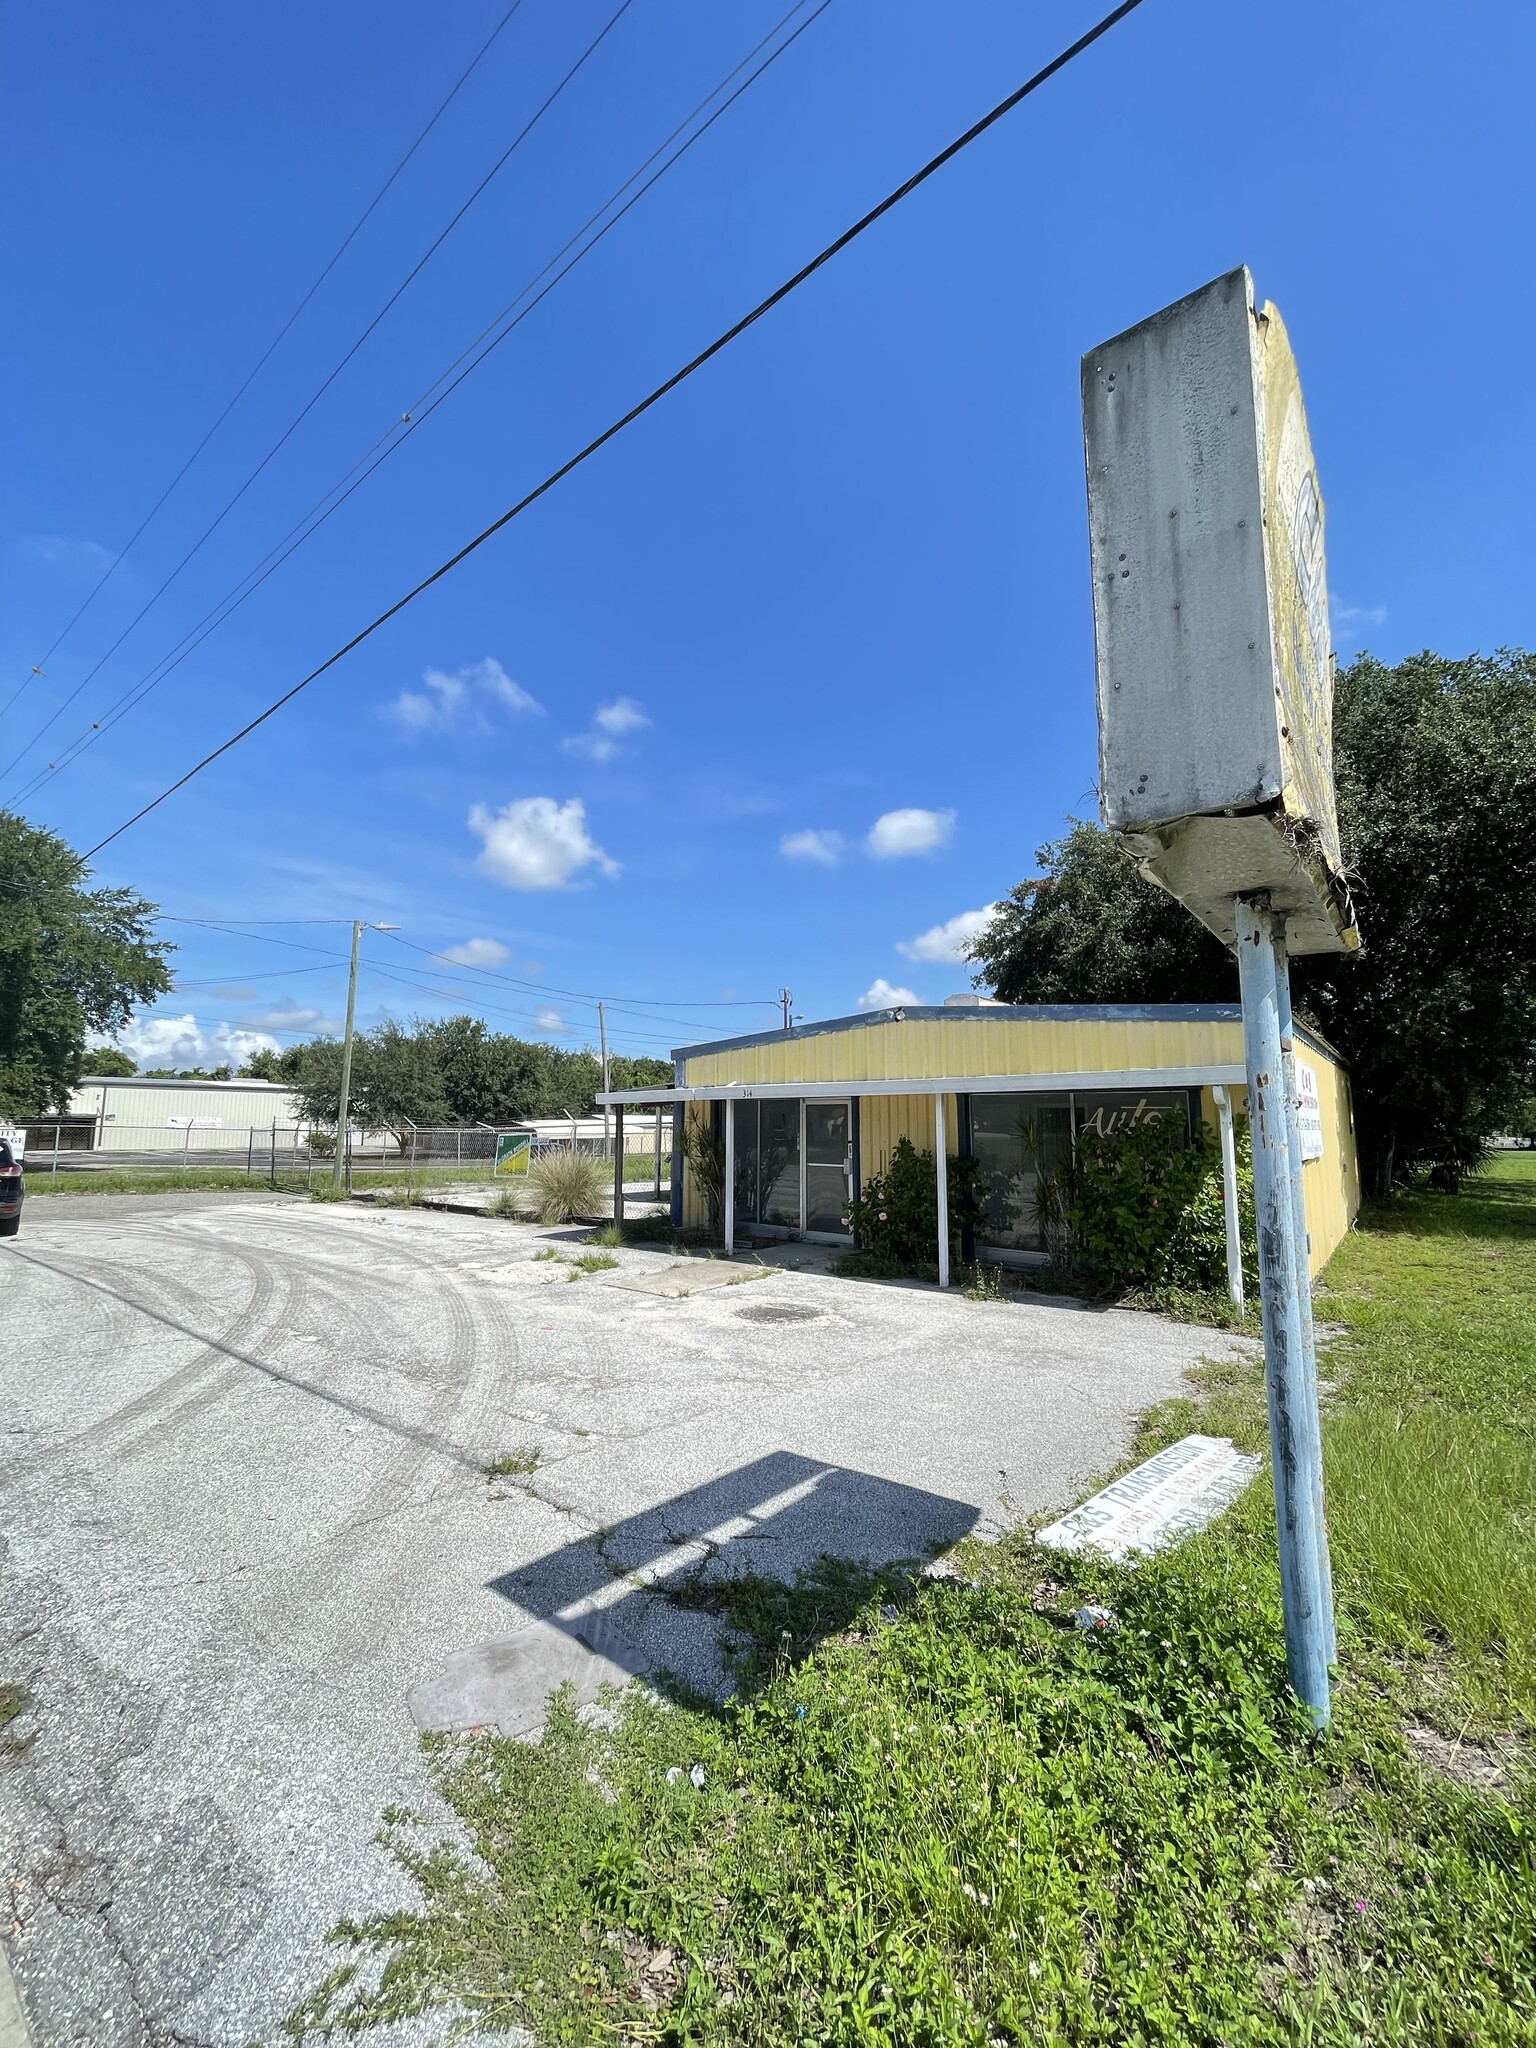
1233, 895, 1331, 1729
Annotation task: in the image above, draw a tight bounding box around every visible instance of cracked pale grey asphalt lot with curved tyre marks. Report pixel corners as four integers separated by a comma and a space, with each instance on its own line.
0, 1196, 1253, 2048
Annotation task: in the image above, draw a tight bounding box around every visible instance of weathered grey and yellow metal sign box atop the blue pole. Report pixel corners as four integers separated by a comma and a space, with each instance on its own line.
1081, 268, 1358, 952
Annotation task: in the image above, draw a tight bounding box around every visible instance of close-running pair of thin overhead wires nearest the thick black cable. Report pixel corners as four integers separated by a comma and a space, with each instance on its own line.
10, 0, 831, 803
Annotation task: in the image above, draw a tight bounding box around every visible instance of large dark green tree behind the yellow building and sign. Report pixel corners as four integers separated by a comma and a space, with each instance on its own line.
971, 651, 1536, 1196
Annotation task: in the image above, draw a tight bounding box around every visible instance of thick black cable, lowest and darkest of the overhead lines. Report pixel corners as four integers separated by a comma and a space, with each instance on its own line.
84, 0, 1141, 860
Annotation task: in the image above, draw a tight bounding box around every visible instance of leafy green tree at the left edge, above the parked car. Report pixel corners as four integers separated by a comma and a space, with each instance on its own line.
0, 811, 172, 1116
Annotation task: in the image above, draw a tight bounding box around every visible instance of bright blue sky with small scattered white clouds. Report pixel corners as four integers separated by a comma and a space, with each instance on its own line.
0, 0, 1536, 1063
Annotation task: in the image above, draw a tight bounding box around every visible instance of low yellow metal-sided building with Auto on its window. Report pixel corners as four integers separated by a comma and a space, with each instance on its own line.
600, 997, 1360, 1274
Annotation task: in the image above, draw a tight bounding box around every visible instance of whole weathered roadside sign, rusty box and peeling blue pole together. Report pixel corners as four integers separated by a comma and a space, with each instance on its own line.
1083, 268, 1360, 1726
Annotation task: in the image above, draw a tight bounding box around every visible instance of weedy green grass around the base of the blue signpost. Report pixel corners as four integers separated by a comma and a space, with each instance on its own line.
291, 1157, 1536, 2048
